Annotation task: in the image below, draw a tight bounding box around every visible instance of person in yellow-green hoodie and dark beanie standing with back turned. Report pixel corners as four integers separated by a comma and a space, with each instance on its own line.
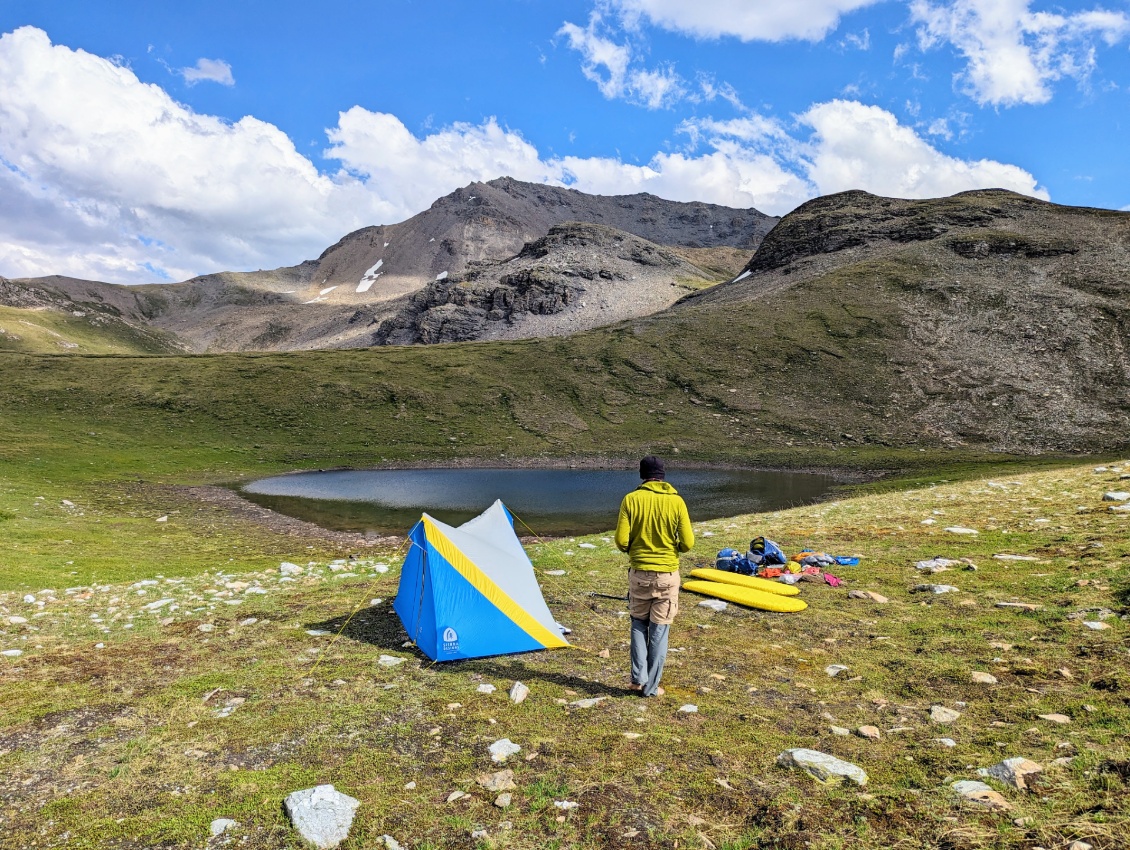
616, 454, 695, 696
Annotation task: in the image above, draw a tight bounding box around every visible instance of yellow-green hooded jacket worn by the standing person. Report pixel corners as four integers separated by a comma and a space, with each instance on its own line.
616, 482, 695, 573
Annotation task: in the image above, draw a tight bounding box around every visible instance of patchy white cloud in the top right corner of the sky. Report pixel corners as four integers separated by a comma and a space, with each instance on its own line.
910, 0, 1130, 106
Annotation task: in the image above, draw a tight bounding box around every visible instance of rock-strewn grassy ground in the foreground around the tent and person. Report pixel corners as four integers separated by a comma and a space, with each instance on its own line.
0, 456, 1130, 850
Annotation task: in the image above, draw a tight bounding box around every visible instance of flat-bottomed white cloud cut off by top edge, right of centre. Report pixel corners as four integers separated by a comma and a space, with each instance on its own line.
611, 0, 883, 42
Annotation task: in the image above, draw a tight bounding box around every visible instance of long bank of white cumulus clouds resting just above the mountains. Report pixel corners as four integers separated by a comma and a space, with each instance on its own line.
0, 27, 1046, 283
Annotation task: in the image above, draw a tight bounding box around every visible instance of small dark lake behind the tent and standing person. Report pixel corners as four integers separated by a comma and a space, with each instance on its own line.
241, 469, 835, 536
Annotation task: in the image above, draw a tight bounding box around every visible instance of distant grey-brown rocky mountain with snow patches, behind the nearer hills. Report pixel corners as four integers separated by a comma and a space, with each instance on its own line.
0, 177, 777, 353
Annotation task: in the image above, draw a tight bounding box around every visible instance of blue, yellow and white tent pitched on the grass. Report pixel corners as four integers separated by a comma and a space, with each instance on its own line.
392, 501, 568, 661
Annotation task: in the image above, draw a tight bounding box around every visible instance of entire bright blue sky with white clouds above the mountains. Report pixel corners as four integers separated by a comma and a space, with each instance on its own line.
0, 0, 1130, 283
